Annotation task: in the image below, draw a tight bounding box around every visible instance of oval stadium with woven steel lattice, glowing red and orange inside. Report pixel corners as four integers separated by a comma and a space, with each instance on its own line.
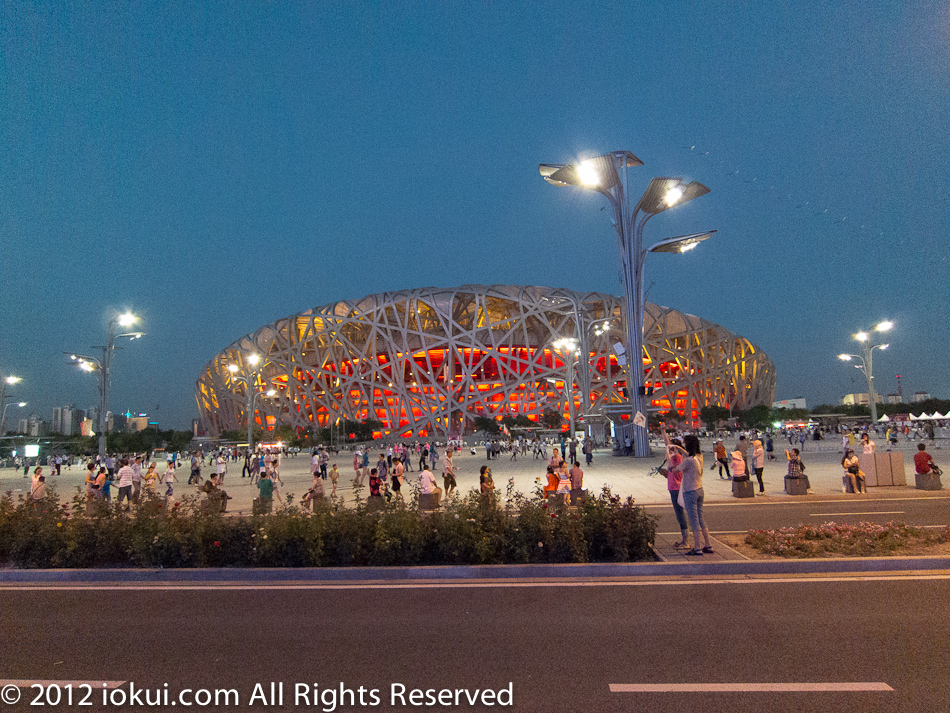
195, 285, 775, 438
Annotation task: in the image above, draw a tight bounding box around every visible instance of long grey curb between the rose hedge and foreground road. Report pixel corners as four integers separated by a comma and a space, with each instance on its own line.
0, 556, 950, 584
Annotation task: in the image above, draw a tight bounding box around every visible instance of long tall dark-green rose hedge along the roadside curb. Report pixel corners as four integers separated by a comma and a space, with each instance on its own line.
0, 486, 656, 568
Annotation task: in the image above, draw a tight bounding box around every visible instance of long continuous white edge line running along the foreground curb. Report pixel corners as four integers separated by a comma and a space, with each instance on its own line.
0, 570, 950, 592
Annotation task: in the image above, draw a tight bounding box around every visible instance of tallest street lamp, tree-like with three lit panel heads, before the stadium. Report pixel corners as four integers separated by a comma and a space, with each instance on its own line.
538, 151, 716, 458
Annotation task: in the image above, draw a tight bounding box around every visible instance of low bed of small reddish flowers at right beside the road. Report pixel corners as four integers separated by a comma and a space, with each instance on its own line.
745, 522, 950, 557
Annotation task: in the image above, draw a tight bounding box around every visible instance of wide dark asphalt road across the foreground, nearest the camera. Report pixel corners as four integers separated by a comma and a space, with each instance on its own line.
0, 573, 950, 713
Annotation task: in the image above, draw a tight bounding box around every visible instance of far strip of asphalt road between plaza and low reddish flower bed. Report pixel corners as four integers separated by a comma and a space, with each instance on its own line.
645, 493, 950, 536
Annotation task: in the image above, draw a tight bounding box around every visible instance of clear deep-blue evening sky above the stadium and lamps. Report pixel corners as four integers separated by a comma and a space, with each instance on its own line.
0, 0, 950, 428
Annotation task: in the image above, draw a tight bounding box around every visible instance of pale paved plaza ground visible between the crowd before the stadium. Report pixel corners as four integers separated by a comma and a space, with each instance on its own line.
0, 438, 950, 513
